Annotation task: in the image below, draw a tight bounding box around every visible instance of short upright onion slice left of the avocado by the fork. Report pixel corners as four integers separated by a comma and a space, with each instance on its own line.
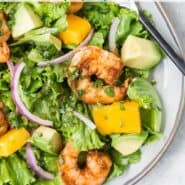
109, 17, 120, 52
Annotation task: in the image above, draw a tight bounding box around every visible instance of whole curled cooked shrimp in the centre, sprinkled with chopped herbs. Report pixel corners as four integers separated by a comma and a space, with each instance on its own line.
69, 46, 127, 104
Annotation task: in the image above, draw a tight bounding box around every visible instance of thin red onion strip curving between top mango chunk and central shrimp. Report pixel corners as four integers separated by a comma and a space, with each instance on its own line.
37, 29, 94, 67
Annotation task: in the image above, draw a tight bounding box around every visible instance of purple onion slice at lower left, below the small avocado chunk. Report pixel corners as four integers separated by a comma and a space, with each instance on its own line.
26, 143, 54, 180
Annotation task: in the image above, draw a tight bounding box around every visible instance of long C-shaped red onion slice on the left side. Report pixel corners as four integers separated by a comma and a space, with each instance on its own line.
11, 62, 53, 126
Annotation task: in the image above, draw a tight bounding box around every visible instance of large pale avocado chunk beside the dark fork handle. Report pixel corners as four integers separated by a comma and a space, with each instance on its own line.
121, 35, 162, 70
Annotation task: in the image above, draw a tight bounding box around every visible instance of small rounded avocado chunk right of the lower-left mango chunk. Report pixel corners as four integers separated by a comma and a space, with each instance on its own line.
30, 126, 62, 154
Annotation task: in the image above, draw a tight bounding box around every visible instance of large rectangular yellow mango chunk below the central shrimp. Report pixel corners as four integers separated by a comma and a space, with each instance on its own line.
92, 101, 141, 135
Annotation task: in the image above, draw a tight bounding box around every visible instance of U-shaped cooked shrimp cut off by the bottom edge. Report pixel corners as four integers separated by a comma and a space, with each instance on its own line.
59, 143, 112, 185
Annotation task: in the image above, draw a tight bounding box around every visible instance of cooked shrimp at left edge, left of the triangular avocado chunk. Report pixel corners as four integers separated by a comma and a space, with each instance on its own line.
0, 12, 10, 62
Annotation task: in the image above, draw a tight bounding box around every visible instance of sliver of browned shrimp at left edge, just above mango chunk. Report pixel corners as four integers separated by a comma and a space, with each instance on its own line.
0, 102, 8, 136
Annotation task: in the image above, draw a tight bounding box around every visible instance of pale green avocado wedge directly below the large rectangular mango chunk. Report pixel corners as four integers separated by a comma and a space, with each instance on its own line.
111, 131, 148, 156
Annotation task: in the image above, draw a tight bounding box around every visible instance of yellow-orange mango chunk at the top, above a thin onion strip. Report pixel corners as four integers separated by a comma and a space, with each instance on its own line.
59, 14, 91, 45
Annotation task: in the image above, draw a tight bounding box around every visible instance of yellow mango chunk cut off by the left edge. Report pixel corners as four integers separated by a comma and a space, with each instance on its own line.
0, 128, 30, 157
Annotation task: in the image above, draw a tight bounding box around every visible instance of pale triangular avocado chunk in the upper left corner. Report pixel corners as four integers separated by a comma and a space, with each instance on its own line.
12, 4, 43, 38
